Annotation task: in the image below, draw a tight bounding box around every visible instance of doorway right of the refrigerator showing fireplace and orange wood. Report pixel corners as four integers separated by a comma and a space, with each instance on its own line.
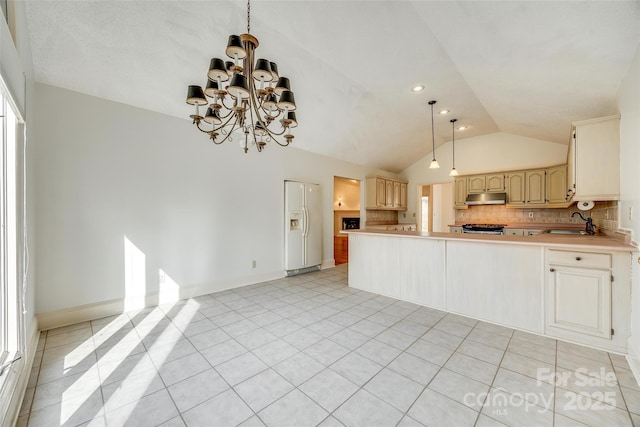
333, 176, 364, 265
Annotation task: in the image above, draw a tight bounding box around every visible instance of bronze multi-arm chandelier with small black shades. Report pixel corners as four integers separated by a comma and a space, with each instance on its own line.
187, 0, 298, 153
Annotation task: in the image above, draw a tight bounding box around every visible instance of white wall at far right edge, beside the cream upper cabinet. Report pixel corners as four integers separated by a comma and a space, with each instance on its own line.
618, 49, 640, 366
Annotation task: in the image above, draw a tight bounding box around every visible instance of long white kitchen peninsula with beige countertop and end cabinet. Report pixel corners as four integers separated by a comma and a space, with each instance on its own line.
348, 230, 637, 353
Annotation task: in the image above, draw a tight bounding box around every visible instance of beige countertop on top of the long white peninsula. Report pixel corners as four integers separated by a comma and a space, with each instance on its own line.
341, 229, 638, 252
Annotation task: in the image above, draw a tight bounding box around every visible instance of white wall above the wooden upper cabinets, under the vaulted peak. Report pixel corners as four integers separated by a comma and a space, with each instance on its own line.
400, 132, 571, 222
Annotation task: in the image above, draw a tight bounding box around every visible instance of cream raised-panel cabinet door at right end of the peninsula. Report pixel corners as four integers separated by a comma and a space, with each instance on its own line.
547, 265, 611, 339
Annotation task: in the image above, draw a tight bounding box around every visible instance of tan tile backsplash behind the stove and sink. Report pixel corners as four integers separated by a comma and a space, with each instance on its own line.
456, 201, 618, 230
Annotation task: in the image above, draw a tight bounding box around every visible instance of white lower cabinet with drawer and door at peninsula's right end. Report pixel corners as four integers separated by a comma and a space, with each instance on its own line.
545, 249, 630, 351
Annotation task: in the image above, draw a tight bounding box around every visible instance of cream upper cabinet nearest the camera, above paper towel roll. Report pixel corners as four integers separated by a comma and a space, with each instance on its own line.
569, 115, 620, 200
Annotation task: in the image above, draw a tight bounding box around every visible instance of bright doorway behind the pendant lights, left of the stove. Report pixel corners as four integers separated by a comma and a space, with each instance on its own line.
416, 182, 455, 233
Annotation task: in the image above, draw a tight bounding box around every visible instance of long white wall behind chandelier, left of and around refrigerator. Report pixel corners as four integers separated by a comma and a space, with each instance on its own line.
36, 84, 396, 313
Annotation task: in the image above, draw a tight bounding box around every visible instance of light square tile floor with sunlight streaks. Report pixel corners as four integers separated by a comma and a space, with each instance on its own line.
18, 265, 640, 427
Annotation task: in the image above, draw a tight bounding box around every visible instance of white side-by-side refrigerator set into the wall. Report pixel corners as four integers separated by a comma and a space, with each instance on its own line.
284, 181, 322, 276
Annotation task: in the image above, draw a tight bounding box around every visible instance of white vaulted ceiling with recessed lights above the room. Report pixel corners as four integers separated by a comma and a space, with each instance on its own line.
26, 0, 640, 172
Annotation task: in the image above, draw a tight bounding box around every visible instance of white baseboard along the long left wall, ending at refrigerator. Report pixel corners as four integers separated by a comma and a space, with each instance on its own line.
37, 271, 284, 331
